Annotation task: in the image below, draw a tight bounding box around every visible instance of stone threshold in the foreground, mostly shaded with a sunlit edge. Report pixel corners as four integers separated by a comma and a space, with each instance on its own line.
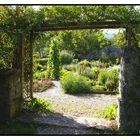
17, 112, 118, 135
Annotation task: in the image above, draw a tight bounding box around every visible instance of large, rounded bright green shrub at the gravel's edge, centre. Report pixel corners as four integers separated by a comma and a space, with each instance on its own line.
60, 72, 92, 94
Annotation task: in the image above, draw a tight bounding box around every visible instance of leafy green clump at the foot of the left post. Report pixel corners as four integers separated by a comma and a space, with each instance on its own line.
28, 98, 50, 112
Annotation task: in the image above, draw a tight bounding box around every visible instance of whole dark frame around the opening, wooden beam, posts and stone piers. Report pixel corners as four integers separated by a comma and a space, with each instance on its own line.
0, 21, 140, 131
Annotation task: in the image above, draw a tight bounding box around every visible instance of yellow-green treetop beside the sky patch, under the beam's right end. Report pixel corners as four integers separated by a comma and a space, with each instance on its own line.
111, 32, 127, 47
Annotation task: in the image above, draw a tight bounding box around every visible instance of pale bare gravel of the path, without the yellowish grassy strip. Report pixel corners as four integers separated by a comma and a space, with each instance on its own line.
34, 81, 117, 108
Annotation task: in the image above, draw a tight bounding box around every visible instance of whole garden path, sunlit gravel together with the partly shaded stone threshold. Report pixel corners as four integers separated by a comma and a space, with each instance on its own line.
18, 81, 117, 135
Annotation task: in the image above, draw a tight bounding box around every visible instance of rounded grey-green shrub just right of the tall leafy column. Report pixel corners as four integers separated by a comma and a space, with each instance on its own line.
60, 50, 74, 65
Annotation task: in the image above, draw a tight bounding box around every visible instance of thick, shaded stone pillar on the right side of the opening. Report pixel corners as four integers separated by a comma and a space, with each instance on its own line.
119, 46, 140, 134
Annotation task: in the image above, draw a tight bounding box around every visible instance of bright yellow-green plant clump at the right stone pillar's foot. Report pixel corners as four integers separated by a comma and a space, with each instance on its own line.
99, 103, 117, 120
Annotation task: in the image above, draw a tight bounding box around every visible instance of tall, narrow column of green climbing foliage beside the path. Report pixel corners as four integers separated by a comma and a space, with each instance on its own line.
47, 40, 60, 79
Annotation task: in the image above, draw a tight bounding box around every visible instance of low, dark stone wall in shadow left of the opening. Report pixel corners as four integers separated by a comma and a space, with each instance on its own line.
0, 70, 22, 122
